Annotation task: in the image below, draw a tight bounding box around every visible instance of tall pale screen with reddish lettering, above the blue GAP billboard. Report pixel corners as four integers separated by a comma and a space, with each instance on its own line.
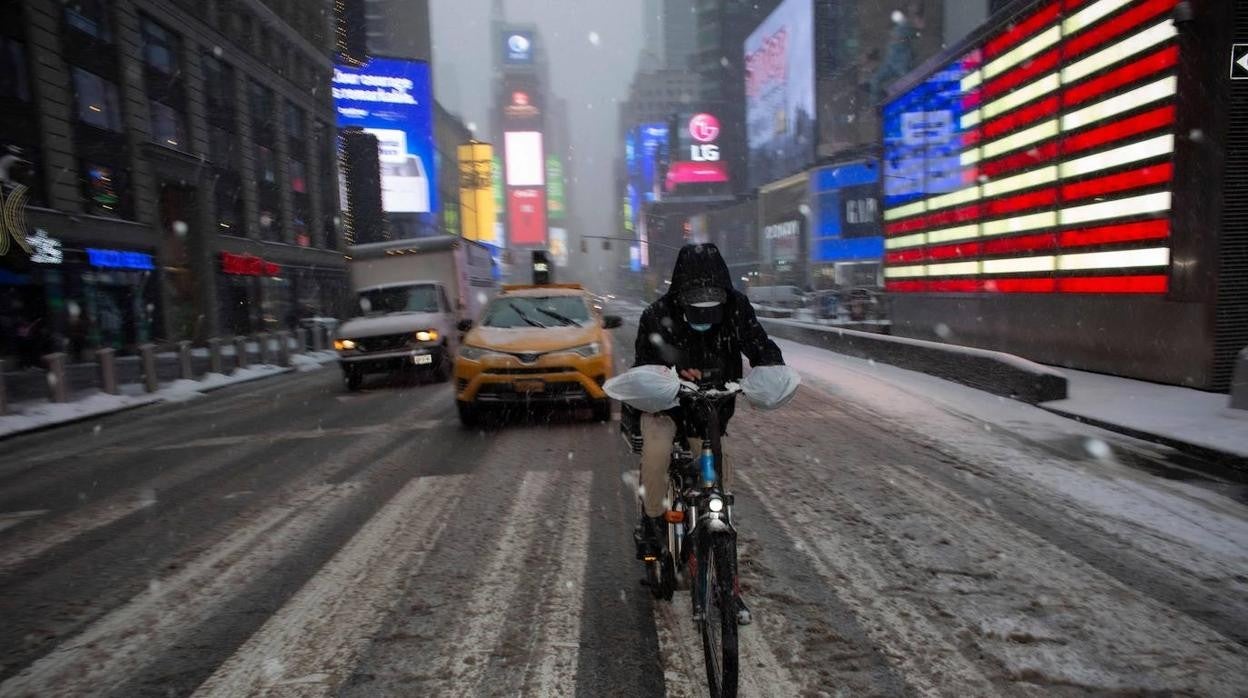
745, 0, 816, 187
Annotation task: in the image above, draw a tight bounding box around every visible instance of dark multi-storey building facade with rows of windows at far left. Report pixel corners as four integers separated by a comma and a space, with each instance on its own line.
0, 0, 346, 369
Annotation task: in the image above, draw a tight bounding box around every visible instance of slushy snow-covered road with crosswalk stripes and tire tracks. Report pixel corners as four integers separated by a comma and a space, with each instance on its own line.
0, 318, 1248, 697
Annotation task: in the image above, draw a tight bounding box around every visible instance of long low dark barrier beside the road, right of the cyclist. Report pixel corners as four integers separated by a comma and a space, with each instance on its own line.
759, 318, 1067, 405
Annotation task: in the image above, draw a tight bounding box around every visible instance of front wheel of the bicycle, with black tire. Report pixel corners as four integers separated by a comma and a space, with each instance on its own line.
698, 533, 738, 698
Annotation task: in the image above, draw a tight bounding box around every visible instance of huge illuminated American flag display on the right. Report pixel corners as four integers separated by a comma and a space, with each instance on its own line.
884, 2, 1179, 293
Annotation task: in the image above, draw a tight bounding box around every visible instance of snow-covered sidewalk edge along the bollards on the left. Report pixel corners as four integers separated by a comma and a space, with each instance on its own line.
0, 351, 338, 438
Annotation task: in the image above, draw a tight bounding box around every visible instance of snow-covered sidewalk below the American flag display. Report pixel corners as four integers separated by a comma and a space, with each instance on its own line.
1042, 368, 1248, 458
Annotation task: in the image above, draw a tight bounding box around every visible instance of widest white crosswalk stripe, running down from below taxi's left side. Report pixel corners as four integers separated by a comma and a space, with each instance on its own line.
195, 476, 468, 698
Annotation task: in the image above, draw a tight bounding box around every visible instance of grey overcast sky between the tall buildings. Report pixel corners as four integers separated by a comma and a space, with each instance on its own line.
429, 0, 643, 257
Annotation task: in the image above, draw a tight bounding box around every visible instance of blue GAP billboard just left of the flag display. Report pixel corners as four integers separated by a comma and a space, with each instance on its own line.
810, 160, 884, 262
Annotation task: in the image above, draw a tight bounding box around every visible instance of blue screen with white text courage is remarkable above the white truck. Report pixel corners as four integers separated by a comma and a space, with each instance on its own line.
333, 59, 438, 214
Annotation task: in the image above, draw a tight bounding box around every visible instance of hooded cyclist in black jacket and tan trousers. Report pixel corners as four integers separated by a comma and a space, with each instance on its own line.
633, 243, 784, 623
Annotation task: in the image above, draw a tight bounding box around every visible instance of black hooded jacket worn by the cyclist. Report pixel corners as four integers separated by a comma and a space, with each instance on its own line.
633, 243, 784, 426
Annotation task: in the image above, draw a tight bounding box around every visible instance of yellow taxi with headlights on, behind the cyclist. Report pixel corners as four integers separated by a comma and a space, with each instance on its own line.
454, 283, 622, 427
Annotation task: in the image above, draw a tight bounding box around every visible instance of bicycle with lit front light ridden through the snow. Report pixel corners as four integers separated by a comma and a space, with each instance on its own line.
633, 381, 741, 698
